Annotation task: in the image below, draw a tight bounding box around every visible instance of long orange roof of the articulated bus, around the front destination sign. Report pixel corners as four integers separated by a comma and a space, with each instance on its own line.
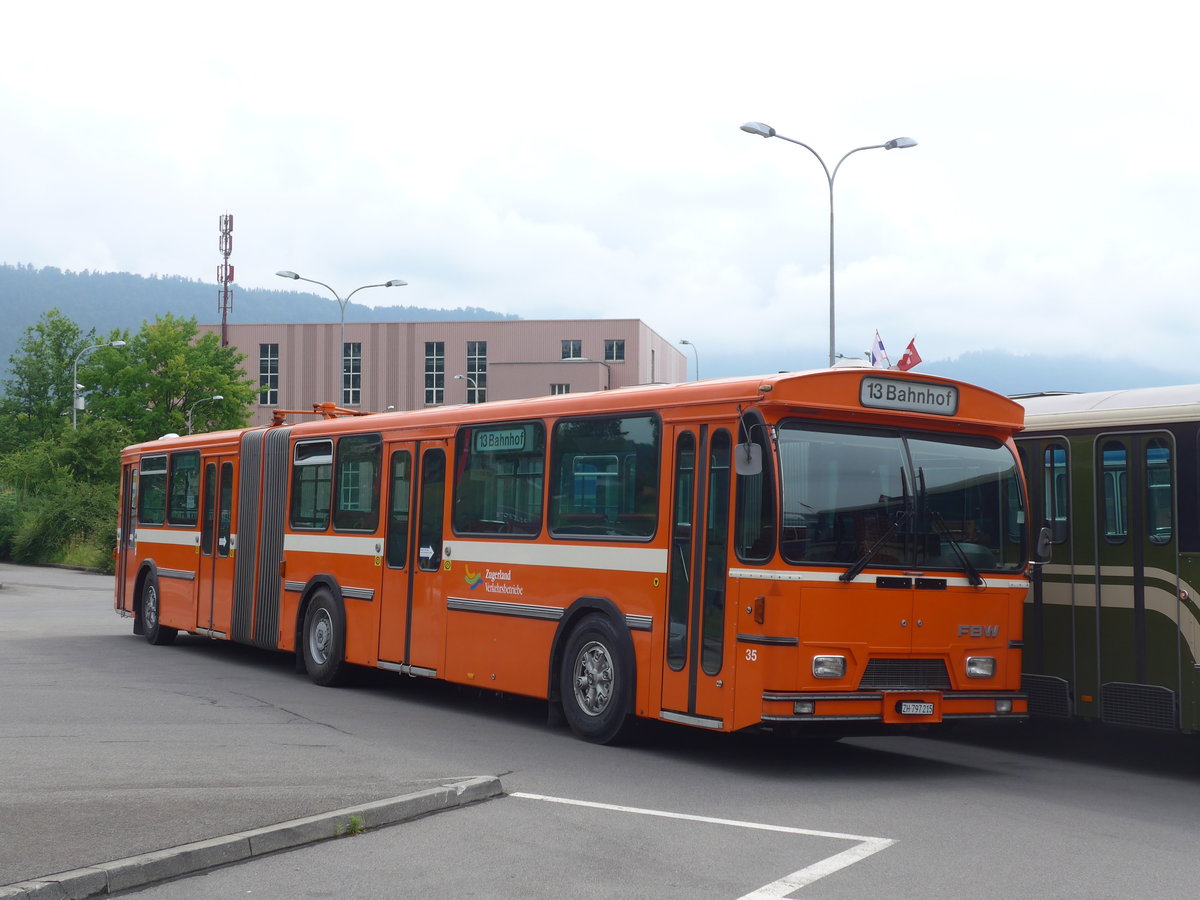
119, 366, 1022, 452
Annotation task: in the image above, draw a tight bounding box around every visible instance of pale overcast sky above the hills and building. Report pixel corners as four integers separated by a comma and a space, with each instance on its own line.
0, 0, 1200, 380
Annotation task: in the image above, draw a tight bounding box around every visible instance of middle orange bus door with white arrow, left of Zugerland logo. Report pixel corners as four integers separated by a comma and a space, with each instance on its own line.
378, 443, 446, 674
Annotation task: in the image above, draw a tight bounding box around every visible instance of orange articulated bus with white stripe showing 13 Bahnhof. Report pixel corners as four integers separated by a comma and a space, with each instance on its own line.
114, 367, 1030, 743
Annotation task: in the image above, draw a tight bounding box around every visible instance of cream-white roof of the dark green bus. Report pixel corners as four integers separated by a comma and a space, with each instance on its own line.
1015, 384, 1200, 431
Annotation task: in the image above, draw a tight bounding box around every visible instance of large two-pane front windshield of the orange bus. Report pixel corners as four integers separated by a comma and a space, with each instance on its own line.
779, 420, 1025, 581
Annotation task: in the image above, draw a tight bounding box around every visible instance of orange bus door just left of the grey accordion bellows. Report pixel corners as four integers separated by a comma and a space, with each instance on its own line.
196, 455, 235, 637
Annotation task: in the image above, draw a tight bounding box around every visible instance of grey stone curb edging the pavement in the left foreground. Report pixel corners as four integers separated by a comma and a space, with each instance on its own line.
0, 776, 503, 900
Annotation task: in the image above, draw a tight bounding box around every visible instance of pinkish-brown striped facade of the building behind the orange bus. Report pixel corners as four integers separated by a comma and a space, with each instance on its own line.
200, 319, 688, 425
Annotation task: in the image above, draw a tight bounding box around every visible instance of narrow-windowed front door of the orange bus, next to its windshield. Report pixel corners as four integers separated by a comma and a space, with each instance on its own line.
662, 425, 733, 728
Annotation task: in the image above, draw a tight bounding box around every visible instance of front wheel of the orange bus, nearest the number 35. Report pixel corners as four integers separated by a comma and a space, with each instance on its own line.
559, 616, 634, 744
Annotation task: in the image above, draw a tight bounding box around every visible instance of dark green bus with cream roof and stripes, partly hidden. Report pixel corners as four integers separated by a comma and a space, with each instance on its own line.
1015, 385, 1200, 732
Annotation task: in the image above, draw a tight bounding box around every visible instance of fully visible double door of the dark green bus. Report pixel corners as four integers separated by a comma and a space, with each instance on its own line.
1094, 433, 1178, 730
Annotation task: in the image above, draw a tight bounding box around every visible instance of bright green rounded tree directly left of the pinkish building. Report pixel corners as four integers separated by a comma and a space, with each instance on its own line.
88, 313, 256, 440
